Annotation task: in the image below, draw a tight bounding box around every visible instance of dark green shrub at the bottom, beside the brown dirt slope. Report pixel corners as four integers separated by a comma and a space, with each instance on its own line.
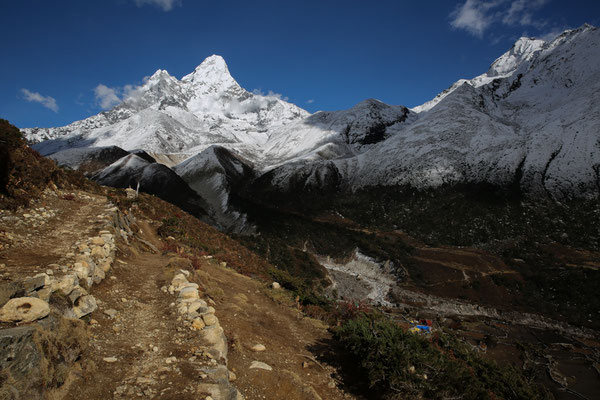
335, 314, 549, 400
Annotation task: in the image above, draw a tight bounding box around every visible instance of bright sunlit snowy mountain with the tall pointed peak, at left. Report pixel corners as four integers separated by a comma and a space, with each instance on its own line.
24, 55, 309, 156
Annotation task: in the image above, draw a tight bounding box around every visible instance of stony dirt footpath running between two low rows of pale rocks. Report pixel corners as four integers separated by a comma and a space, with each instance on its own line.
66, 253, 210, 399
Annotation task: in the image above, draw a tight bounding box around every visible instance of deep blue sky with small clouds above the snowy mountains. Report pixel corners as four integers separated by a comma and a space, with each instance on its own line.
0, 0, 600, 127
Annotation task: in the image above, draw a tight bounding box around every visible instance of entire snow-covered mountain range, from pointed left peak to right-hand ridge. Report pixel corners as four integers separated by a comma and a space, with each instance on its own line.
24, 25, 600, 230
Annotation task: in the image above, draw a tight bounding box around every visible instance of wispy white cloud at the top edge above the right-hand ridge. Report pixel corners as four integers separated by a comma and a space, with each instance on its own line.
450, 0, 549, 38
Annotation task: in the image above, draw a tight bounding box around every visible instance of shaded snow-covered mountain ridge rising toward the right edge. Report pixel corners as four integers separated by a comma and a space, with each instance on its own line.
263, 25, 600, 197
